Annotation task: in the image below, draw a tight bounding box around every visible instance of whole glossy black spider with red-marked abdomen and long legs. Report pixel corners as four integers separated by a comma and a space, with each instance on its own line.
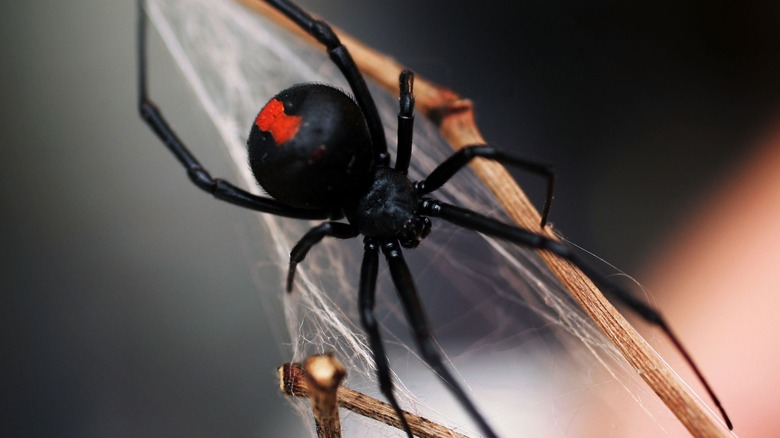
138, 0, 731, 437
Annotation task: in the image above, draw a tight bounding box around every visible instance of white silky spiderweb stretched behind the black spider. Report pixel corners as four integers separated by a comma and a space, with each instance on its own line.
142, 0, 679, 436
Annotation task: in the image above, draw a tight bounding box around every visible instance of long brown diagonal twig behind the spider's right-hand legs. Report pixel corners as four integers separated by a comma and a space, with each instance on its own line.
247, 0, 734, 437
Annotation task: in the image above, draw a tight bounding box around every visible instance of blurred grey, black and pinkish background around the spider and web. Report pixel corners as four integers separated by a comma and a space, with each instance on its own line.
0, 0, 780, 436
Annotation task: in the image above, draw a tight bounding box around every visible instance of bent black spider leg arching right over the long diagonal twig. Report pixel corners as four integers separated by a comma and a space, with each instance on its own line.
416, 145, 555, 227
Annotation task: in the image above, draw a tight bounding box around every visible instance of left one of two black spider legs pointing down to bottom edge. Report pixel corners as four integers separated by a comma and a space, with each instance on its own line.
358, 237, 412, 438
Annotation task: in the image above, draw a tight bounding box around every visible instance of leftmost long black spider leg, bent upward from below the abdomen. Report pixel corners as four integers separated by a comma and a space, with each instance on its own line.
138, 0, 330, 219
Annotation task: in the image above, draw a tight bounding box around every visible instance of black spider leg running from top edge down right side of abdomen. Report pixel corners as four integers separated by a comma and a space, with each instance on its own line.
265, 0, 390, 166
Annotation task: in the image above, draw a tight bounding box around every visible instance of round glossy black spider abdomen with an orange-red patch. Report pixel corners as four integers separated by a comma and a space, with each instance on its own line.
247, 84, 372, 209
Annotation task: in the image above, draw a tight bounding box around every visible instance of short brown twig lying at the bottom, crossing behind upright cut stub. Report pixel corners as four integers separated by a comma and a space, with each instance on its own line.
278, 355, 466, 438
